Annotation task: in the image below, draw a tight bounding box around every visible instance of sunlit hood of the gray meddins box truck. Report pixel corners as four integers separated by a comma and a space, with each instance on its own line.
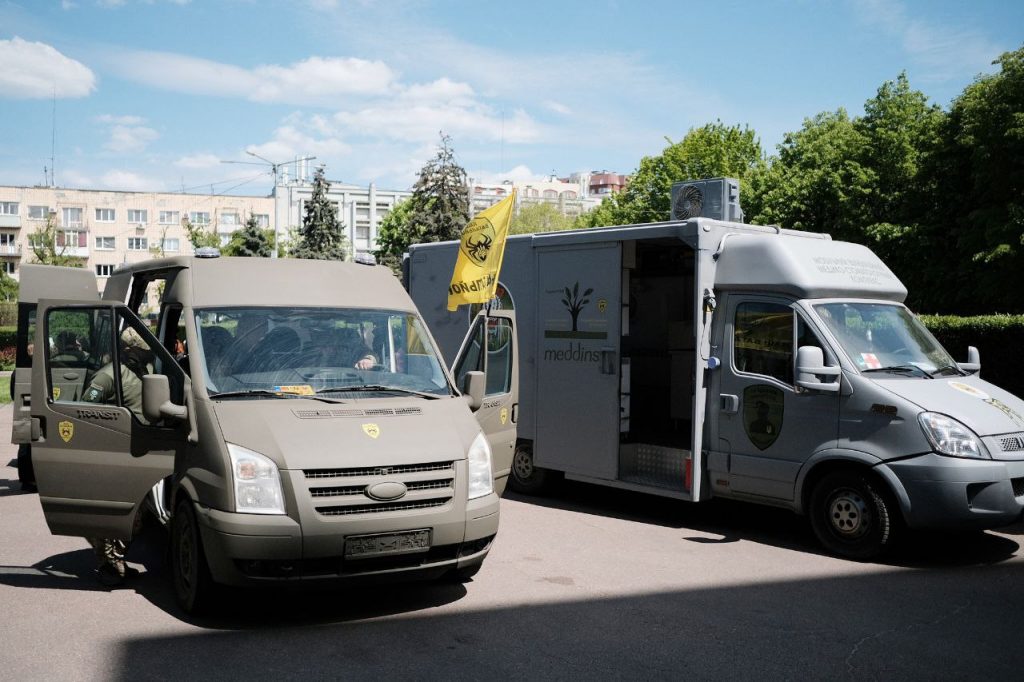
871, 375, 1024, 436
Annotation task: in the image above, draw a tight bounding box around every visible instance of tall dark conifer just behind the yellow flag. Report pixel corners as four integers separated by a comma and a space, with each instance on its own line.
377, 133, 469, 262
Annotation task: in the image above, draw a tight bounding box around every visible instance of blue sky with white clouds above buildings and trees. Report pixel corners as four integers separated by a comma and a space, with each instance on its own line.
0, 0, 1024, 195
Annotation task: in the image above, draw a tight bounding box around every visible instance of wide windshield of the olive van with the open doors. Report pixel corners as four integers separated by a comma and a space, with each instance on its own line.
193, 307, 452, 398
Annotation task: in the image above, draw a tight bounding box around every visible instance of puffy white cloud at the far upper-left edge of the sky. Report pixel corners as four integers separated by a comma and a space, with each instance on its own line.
0, 36, 96, 99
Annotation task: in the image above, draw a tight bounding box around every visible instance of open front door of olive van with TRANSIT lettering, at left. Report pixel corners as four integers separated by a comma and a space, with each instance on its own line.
30, 300, 189, 540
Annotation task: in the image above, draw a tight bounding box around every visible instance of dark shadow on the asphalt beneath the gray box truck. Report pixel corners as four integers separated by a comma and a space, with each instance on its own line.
505, 481, 1024, 568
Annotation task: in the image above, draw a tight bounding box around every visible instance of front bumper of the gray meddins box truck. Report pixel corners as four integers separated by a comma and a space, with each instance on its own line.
878, 453, 1024, 530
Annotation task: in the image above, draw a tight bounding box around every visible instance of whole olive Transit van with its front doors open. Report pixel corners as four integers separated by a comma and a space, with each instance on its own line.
13, 257, 517, 611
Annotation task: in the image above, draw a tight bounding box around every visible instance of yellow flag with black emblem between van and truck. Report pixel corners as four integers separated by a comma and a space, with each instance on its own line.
449, 189, 515, 310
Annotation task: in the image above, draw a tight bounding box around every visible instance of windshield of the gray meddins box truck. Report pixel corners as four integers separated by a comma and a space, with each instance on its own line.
814, 302, 961, 377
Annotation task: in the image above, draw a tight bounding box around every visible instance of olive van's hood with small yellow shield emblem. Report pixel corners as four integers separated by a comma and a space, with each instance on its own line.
213, 398, 480, 469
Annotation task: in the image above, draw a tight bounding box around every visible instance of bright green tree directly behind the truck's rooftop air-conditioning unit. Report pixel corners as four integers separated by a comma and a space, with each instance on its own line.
577, 121, 764, 227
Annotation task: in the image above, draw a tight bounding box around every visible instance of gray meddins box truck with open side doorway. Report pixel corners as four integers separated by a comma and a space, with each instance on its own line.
406, 218, 1024, 558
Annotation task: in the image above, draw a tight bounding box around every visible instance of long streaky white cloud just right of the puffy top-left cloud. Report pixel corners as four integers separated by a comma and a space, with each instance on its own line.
109, 51, 395, 103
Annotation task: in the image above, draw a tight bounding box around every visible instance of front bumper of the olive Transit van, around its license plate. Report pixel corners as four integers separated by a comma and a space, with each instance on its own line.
196, 494, 499, 587
